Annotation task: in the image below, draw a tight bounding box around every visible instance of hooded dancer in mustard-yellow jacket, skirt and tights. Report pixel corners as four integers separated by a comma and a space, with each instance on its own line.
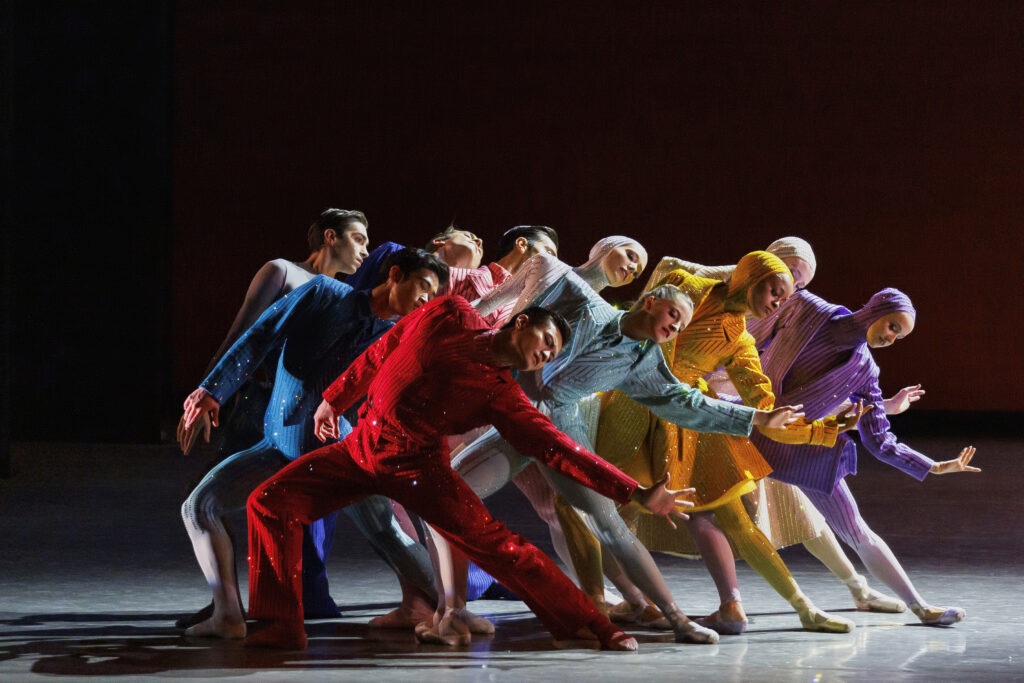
566, 252, 859, 633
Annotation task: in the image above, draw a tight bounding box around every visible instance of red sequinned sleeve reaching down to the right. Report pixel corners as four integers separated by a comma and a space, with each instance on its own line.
486, 383, 637, 504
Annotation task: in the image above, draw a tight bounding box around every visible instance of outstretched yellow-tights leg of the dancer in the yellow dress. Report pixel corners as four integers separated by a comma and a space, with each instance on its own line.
715, 499, 853, 633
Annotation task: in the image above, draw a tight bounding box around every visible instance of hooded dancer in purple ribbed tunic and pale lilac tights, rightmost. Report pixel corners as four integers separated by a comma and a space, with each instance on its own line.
748, 289, 980, 626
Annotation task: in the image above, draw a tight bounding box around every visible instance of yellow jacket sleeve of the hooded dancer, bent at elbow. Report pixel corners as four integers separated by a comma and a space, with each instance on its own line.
725, 333, 839, 449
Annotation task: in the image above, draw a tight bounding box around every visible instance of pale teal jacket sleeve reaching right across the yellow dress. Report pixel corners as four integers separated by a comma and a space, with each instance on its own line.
615, 349, 755, 436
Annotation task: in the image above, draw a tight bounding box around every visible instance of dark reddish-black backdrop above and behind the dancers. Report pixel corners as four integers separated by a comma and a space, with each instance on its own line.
0, 0, 1024, 441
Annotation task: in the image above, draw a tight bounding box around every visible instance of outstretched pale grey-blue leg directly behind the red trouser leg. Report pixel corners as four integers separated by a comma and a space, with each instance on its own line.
542, 468, 718, 643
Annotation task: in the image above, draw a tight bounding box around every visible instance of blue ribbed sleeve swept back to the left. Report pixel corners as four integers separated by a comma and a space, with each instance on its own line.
200, 275, 344, 404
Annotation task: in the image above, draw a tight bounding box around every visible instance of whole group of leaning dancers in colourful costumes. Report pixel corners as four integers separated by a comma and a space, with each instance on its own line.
178, 209, 979, 650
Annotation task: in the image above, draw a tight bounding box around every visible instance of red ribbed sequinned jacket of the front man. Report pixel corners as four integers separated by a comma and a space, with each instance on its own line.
324, 296, 637, 503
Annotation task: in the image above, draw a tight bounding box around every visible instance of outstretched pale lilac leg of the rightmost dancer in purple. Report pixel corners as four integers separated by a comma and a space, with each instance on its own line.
804, 479, 964, 626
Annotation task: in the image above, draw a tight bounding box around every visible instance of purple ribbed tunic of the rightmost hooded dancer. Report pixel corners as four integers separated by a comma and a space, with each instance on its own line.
751, 290, 934, 494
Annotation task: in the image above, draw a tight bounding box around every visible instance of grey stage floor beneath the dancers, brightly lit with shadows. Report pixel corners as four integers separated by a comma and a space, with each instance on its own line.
0, 437, 1024, 681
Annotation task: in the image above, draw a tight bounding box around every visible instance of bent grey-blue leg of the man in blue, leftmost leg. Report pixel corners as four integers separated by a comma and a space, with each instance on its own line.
181, 440, 288, 638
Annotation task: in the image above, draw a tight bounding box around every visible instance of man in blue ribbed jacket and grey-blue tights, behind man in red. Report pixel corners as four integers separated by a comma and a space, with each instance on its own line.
182, 249, 447, 638
